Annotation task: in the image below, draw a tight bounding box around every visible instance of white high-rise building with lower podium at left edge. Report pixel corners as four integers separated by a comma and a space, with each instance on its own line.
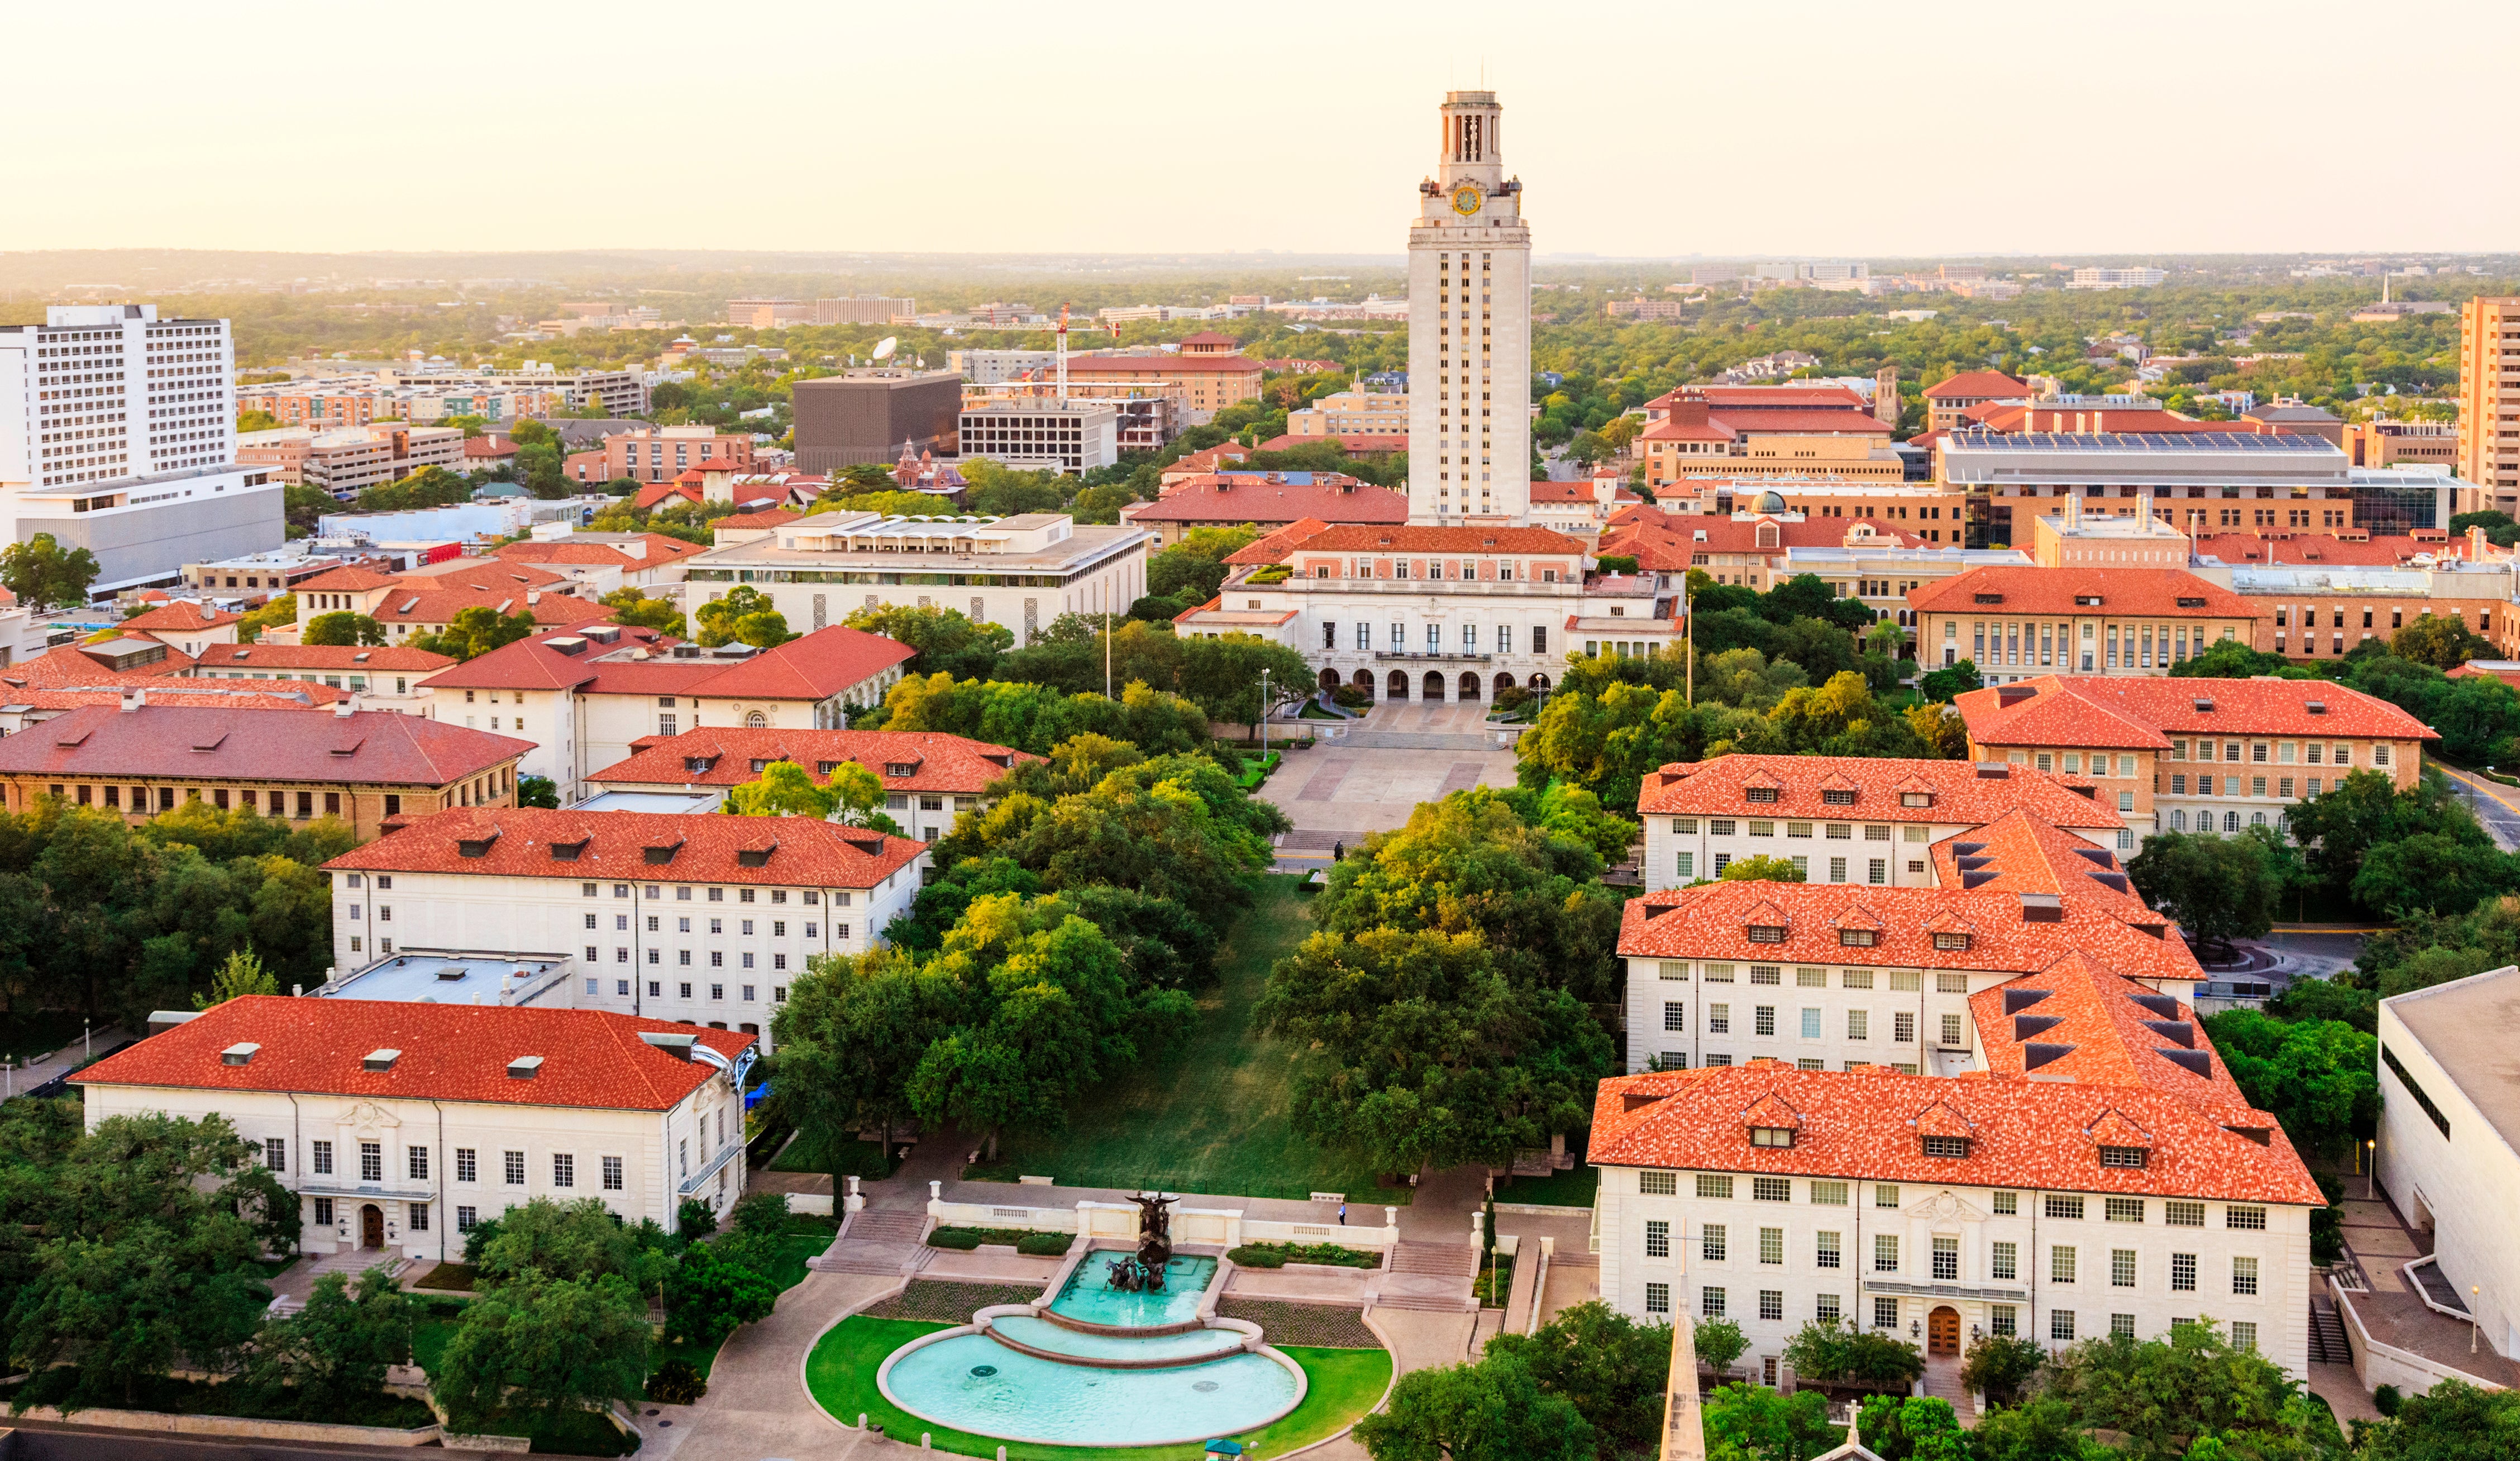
0, 305, 285, 592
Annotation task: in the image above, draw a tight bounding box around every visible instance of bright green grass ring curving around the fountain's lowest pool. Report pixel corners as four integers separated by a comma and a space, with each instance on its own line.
804, 1315, 1391, 1461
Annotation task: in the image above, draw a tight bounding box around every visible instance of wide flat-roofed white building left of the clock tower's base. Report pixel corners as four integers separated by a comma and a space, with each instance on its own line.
683, 512, 1154, 647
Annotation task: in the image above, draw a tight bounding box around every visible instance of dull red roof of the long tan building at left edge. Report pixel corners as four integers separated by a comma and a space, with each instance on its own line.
0, 705, 534, 786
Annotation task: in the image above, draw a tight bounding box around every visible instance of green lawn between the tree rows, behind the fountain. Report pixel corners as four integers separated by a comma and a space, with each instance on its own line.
973, 877, 1409, 1199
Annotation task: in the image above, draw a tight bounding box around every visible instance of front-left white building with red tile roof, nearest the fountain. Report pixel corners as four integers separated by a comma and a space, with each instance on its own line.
78, 995, 753, 1262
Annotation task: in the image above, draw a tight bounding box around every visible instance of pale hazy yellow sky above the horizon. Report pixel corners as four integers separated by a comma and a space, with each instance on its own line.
20, 0, 2520, 257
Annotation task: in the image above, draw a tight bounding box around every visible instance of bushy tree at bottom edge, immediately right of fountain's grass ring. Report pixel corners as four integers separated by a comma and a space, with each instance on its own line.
1356, 1360, 1598, 1461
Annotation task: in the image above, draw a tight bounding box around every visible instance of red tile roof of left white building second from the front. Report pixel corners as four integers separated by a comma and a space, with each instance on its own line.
330, 801, 927, 889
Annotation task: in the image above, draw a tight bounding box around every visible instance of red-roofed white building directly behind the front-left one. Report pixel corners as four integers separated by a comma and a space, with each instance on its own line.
325, 806, 927, 1040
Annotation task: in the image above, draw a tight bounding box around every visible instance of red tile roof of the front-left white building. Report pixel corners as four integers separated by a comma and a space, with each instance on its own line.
78, 995, 753, 1111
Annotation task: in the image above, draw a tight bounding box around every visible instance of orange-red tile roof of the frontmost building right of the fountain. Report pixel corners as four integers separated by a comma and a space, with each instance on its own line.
1588, 1061, 2323, 1206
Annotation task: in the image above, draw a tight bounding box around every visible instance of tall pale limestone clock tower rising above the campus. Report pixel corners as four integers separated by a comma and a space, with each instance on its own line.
1409, 90, 1532, 527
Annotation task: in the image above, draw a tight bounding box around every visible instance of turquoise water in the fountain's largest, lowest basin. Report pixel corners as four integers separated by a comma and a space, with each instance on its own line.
885, 1340, 1295, 1446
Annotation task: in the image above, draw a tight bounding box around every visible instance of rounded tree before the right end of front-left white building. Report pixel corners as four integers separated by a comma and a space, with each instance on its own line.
428, 1269, 650, 1431
